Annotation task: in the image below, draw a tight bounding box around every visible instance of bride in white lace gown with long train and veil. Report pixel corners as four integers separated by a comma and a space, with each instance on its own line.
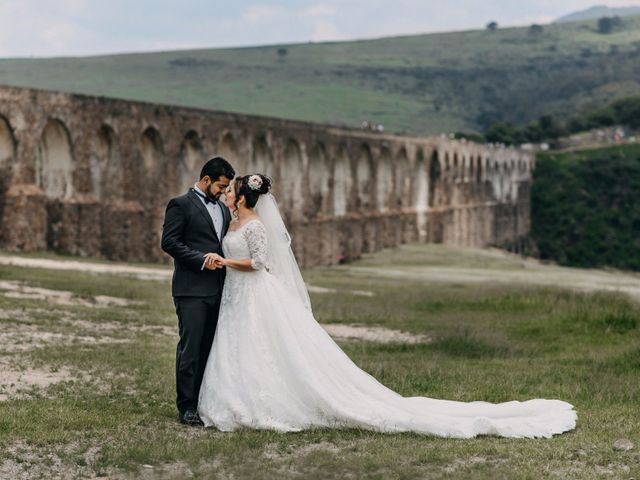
198, 174, 576, 438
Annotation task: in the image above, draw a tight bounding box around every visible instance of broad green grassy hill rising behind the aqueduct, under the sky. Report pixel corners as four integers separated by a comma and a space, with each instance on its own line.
0, 17, 640, 133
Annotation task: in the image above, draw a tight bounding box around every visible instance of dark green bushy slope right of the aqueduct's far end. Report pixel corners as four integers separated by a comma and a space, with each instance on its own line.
531, 145, 640, 270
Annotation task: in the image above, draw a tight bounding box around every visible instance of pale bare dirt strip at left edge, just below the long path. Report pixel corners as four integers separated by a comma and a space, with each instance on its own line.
0, 281, 141, 307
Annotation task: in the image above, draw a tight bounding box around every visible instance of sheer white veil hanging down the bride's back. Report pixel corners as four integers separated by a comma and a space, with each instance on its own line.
255, 193, 311, 310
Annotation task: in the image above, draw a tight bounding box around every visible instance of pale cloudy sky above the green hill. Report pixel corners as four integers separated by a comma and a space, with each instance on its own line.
0, 0, 640, 57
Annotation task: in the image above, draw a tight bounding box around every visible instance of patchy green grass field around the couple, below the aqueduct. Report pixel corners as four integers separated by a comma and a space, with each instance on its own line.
0, 245, 640, 479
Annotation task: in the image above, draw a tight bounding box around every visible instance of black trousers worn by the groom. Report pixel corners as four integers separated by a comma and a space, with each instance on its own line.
173, 295, 220, 413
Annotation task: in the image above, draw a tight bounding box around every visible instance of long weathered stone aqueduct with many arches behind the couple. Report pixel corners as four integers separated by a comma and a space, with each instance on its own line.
0, 87, 534, 266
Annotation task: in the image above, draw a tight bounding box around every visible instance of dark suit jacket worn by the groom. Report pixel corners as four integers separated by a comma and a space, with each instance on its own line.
161, 188, 231, 297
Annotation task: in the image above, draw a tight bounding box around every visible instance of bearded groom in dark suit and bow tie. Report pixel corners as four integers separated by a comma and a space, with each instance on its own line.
162, 157, 235, 425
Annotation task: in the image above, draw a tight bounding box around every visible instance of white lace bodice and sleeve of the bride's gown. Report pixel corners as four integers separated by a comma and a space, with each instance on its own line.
222, 218, 267, 270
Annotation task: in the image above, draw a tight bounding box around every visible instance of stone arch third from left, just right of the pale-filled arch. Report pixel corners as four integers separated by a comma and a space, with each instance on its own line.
90, 124, 125, 201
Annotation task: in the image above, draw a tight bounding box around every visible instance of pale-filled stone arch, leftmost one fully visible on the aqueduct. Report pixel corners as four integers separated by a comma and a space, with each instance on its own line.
36, 119, 74, 198
